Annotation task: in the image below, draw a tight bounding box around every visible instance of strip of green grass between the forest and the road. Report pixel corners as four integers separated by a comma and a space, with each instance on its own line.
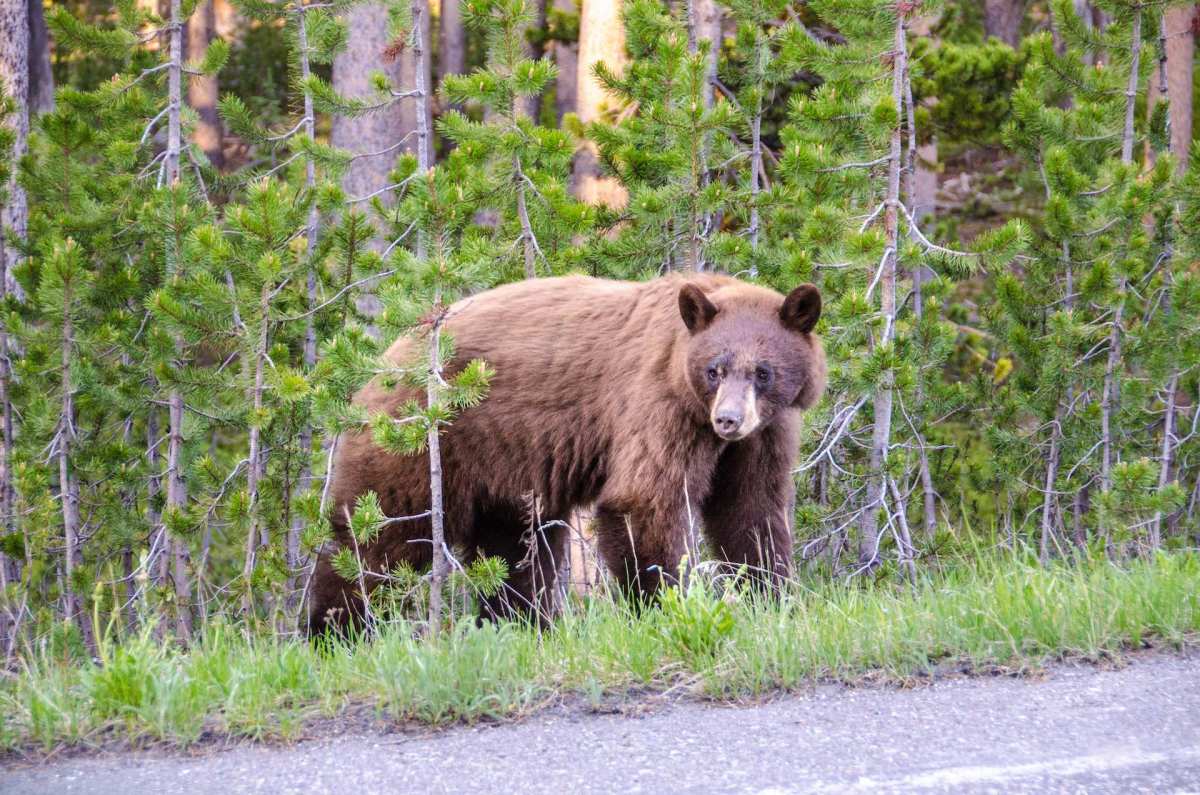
0, 554, 1200, 751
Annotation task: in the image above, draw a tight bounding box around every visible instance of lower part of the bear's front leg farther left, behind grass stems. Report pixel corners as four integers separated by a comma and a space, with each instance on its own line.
596, 503, 688, 599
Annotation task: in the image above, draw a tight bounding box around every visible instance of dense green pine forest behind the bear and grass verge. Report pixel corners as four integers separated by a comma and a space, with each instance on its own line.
0, 0, 1200, 660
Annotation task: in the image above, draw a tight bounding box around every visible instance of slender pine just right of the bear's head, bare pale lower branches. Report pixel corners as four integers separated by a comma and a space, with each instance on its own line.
779, 0, 1022, 572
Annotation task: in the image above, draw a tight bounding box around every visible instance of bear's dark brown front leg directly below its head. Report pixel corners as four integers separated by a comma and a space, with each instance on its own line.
701, 416, 799, 586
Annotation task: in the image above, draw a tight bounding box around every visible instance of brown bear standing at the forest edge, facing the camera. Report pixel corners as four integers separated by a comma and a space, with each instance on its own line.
304, 274, 826, 634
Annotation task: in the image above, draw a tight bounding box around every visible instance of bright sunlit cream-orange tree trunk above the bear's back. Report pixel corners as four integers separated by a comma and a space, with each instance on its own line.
572, 0, 629, 208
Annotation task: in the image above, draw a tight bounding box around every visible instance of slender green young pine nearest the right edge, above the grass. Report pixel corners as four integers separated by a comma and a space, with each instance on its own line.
997, 2, 1188, 558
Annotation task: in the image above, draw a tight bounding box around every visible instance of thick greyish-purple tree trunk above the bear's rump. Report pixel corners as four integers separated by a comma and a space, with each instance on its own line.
330, 2, 431, 205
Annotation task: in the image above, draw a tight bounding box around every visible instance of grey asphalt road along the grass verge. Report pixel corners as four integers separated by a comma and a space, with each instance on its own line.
0, 654, 1200, 795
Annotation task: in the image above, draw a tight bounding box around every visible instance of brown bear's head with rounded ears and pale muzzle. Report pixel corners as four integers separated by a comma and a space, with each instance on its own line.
679, 283, 826, 441
